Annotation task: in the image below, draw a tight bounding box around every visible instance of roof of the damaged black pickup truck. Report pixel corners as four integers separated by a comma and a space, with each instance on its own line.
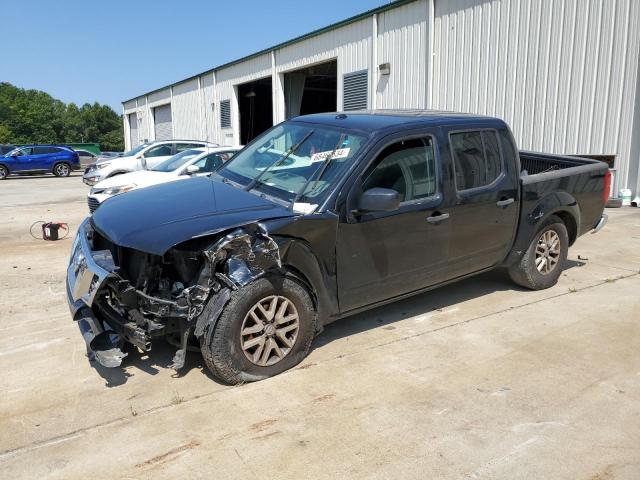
292, 109, 505, 130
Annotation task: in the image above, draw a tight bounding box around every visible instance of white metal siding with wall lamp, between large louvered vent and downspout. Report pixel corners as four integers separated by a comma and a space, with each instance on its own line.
371, 0, 427, 108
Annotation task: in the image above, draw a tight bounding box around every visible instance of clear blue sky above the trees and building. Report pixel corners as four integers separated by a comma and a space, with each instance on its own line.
0, 0, 389, 113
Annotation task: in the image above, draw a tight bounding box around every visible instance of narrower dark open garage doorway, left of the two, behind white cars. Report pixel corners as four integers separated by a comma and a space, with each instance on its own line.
238, 77, 273, 145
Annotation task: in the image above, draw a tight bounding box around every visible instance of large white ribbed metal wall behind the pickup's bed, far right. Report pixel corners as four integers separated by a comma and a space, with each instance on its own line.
432, 0, 640, 191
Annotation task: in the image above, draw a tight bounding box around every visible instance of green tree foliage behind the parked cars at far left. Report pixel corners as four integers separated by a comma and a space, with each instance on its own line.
0, 82, 124, 151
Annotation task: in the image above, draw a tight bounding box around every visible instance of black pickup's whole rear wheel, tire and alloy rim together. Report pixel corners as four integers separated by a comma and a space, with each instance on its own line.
509, 216, 569, 290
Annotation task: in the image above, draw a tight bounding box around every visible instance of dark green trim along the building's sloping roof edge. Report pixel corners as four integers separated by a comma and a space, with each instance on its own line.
122, 0, 419, 106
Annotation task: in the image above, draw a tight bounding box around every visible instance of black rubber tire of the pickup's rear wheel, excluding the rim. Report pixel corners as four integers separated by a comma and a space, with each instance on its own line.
509, 215, 569, 290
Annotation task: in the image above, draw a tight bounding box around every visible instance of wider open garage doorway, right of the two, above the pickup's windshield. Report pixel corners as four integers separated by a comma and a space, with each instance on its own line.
284, 60, 338, 118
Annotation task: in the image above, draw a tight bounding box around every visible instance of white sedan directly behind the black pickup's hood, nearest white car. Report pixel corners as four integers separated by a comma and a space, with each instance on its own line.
88, 147, 242, 213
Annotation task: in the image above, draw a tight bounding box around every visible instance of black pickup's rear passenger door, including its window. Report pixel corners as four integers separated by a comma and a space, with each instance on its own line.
449, 128, 519, 277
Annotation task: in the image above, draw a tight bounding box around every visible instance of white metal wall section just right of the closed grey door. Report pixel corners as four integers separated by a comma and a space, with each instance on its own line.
171, 78, 202, 140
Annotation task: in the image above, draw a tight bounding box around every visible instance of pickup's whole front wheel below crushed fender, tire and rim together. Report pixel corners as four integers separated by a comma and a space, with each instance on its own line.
200, 276, 317, 384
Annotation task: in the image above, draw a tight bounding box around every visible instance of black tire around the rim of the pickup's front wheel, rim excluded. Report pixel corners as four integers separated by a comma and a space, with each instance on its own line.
200, 276, 317, 385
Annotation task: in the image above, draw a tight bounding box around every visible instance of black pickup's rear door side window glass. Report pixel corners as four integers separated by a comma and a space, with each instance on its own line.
450, 130, 502, 191
